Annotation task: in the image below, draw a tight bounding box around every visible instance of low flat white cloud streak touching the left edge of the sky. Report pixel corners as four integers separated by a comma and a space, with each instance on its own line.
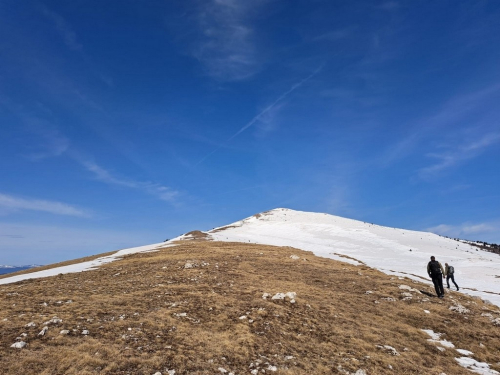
0, 193, 89, 217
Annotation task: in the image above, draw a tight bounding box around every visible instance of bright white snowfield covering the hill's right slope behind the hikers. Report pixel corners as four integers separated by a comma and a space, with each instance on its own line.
202, 208, 500, 306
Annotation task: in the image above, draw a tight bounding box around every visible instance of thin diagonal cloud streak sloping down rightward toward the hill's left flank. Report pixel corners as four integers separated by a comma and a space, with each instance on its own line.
75, 157, 180, 204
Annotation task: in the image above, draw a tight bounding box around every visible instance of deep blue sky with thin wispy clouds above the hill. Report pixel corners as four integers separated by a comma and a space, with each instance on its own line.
0, 0, 500, 264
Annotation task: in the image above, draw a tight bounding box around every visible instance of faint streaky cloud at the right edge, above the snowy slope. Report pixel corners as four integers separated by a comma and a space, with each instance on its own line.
419, 133, 500, 178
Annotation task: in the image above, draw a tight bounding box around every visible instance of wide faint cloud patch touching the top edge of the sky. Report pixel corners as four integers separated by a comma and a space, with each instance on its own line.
194, 0, 265, 81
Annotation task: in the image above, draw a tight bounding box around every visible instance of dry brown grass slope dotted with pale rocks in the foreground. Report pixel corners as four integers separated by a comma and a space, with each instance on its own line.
0, 241, 500, 375
